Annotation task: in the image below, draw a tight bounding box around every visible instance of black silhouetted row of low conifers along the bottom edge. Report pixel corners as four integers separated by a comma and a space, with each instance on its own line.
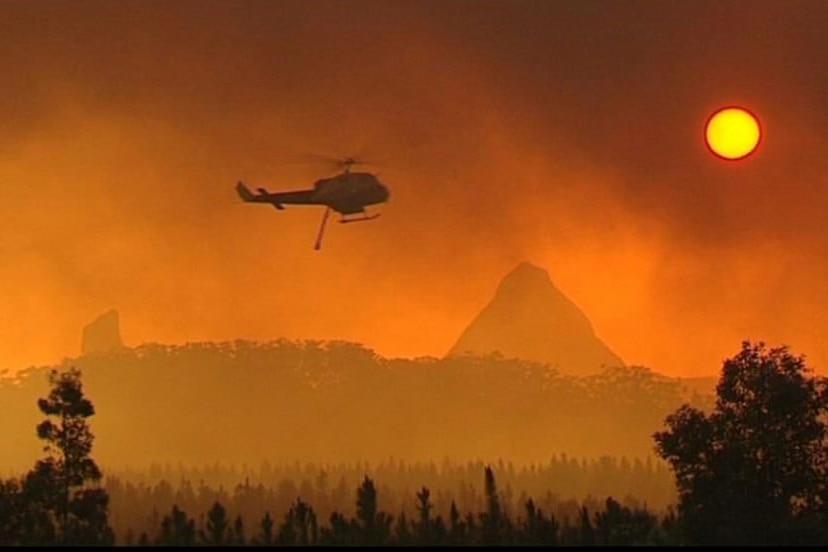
124, 467, 682, 546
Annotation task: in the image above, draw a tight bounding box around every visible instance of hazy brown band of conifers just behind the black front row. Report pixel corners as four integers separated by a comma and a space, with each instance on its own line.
104, 455, 676, 541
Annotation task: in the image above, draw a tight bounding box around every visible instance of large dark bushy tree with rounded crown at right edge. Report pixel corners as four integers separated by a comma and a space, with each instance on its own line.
654, 342, 828, 544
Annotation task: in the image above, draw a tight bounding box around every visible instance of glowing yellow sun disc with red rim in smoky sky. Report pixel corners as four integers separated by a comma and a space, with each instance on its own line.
704, 106, 762, 161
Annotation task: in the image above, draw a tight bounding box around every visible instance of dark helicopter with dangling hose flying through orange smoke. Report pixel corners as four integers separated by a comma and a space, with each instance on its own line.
236, 157, 391, 250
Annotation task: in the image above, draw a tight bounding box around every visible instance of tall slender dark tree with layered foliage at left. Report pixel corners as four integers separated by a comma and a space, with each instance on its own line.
23, 368, 114, 545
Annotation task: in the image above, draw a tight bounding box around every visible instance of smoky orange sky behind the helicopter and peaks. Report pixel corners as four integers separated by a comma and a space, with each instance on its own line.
0, 0, 828, 375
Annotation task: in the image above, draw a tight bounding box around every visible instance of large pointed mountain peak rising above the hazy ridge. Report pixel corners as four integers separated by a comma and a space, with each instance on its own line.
449, 262, 624, 375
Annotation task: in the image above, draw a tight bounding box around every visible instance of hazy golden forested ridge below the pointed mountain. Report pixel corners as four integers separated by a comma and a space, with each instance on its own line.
0, 340, 712, 466
